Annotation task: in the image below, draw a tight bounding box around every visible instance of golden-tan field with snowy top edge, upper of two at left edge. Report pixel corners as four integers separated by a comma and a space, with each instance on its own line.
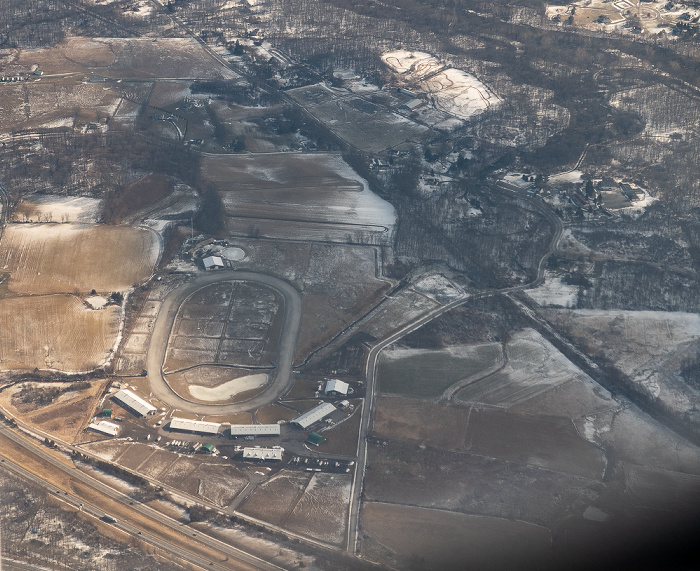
0, 224, 160, 294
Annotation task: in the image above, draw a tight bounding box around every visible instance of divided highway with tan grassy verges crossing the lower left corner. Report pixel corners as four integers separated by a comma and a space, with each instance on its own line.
0, 426, 279, 570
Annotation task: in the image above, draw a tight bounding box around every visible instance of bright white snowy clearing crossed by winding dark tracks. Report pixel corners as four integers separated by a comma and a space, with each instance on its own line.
382, 50, 500, 119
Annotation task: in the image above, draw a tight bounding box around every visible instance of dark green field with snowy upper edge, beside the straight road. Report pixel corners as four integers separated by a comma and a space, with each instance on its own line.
377, 343, 502, 398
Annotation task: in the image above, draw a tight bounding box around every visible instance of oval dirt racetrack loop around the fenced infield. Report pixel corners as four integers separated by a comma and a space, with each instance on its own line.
146, 270, 301, 414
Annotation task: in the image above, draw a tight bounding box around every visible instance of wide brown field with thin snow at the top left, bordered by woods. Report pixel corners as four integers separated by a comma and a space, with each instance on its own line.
17, 37, 238, 79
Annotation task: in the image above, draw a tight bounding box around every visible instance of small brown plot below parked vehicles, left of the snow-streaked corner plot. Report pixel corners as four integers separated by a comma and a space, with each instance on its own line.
239, 470, 311, 525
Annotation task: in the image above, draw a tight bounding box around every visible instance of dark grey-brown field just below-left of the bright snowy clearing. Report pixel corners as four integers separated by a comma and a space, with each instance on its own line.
287, 84, 428, 153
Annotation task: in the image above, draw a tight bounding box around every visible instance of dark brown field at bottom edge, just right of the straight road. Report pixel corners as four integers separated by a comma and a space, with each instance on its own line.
361, 502, 551, 569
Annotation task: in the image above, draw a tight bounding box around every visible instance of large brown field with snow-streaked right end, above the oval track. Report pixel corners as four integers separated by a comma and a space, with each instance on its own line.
202, 154, 396, 238
